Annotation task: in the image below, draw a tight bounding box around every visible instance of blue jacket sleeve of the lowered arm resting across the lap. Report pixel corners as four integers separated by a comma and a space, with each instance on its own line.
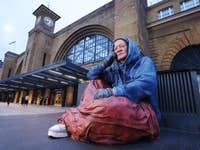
113, 57, 157, 103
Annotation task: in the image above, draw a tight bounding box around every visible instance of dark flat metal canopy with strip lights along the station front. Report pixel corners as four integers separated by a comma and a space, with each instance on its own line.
0, 61, 88, 92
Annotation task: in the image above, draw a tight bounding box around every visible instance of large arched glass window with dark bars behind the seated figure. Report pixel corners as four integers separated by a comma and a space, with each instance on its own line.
66, 34, 112, 64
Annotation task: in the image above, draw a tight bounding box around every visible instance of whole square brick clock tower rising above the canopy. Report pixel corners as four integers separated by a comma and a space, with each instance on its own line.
22, 5, 60, 72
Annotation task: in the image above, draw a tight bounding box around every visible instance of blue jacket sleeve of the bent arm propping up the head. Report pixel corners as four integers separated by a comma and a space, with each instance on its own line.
87, 64, 113, 84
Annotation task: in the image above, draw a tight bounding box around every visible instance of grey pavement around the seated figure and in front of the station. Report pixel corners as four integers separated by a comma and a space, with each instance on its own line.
0, 103, 200, 150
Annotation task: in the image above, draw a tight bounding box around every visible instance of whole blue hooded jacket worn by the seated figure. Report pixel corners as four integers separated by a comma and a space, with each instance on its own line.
87, 37, 161, 121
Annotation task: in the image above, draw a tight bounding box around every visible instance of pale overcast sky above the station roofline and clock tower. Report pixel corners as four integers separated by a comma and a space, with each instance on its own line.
0, 0, 159, 60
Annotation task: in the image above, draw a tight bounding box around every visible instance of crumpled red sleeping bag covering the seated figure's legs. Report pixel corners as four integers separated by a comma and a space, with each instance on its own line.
58, 80, 159, 144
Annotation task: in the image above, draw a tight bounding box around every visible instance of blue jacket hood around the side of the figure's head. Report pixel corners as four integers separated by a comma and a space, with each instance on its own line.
123, 37, 142, 64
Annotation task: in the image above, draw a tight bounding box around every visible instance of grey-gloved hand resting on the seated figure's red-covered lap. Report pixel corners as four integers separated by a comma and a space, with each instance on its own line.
94, 88, 113, 99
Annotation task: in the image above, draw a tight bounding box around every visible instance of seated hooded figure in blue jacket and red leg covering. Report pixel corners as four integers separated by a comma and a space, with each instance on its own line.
48, 37, 161, 144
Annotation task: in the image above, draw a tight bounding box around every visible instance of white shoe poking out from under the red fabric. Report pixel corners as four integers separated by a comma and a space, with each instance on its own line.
48, 124, 68, 138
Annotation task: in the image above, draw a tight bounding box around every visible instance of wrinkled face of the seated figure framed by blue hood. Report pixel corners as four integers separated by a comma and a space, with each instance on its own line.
114, 40, 128, 61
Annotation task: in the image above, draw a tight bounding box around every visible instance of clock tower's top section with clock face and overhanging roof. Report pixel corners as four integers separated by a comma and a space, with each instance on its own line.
33, 5, 60, 33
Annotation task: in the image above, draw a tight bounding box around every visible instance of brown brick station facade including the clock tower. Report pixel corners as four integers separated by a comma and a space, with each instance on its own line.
1, 0, 200, 108
